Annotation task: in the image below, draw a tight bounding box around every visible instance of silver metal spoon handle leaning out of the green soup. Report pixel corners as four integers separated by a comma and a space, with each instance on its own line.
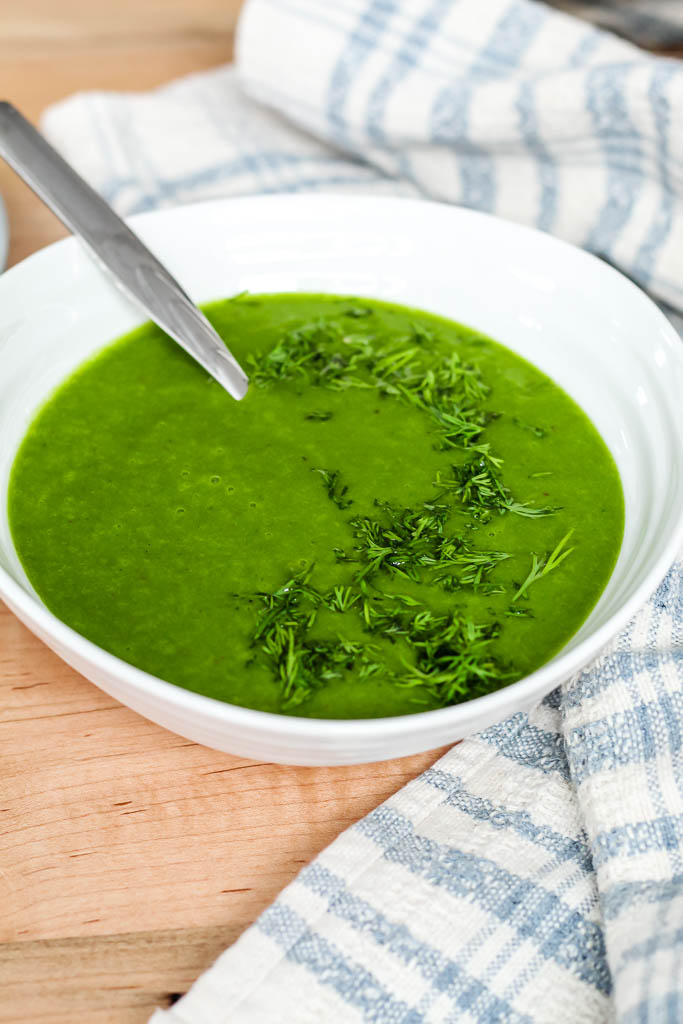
0, 102, 249, 400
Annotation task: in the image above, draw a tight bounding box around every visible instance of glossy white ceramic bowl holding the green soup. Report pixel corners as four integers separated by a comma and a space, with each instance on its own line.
0, 195, 683, 765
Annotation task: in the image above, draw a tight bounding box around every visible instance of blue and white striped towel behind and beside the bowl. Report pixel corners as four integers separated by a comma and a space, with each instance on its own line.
38, 0, 683, 1024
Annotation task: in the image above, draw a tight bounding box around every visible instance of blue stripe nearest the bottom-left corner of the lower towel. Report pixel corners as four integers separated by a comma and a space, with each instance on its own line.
256, 903, 424, 1024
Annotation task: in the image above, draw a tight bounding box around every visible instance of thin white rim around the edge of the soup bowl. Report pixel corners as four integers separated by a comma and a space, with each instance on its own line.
0, 191, 683, 741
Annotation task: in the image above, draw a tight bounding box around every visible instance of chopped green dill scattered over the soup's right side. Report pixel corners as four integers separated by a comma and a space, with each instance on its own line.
242, 311, 573, 709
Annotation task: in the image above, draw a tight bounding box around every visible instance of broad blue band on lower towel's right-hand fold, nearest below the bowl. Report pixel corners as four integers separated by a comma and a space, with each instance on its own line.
567, 692, 683, 783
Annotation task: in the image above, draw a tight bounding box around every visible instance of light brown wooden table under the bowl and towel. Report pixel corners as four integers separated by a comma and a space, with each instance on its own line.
0, 18, 446, 1024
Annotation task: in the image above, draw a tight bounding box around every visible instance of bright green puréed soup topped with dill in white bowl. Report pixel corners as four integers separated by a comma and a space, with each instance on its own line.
9, 295, 624, 718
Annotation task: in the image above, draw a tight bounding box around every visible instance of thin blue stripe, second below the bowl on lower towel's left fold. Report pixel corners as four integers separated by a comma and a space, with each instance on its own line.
420, 768, 593, 873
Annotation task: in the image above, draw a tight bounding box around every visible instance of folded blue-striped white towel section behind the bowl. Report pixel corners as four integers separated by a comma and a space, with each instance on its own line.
44, 0, 683, 306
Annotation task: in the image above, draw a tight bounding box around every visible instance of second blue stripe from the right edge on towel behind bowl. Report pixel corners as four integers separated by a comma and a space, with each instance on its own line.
584, 62, 643, 256
